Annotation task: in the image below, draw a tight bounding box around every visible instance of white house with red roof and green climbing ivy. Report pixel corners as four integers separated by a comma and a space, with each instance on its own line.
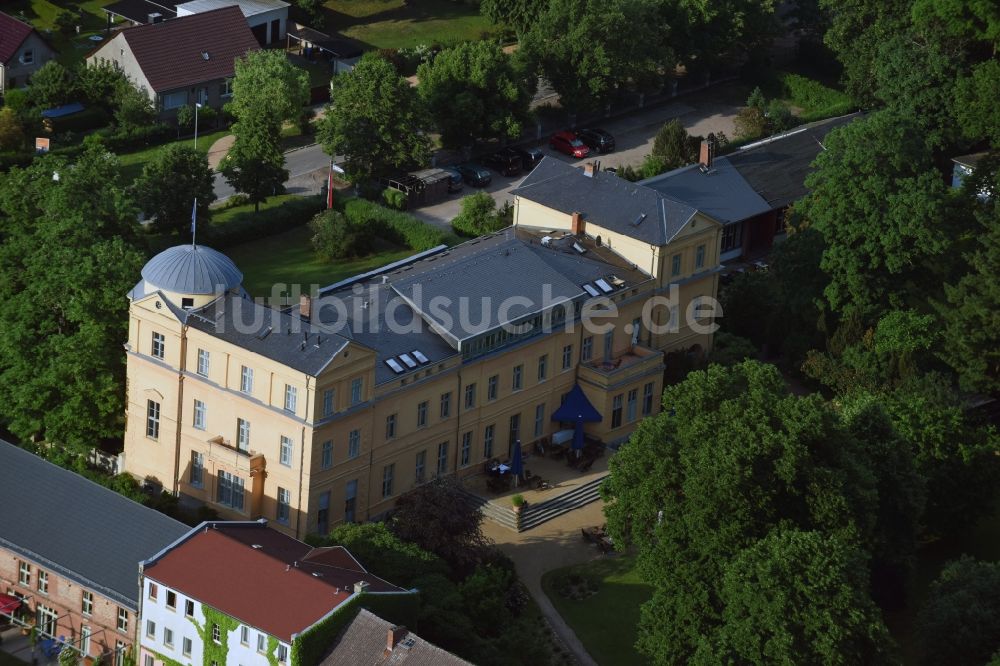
137, 520, 410, 666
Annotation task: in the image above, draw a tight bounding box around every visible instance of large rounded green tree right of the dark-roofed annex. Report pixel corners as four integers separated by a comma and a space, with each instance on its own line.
800, 111, 952, 316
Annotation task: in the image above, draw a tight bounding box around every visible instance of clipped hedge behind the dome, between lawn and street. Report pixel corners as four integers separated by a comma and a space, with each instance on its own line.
205, 194, 324, 248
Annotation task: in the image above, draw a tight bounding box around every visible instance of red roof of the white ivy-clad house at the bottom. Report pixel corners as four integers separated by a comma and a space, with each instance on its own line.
144, 522, 402, 642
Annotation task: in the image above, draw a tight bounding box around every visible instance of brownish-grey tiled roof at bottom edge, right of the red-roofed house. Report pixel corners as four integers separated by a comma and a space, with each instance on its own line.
320, 608, 474, 666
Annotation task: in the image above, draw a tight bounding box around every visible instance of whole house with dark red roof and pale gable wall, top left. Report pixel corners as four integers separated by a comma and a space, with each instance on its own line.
87, 6, 260, 118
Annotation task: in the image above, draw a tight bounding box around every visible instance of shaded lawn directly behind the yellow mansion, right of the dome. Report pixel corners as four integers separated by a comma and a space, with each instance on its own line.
226, 223, 415, 296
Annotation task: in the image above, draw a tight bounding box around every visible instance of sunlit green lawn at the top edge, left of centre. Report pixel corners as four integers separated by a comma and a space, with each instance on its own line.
325, 0, 495, 49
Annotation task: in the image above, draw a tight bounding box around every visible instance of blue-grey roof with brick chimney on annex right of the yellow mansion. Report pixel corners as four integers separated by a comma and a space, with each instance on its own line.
641, 157, 771, 223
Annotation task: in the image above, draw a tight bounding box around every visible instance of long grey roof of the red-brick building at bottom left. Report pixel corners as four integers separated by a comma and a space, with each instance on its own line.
0, 440, 190, 611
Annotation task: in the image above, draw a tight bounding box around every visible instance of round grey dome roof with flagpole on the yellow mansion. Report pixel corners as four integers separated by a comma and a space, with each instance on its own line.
142, 245, 243, 294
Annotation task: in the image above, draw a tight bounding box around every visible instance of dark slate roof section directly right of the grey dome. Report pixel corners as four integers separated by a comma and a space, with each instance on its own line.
186, 294, 348, 377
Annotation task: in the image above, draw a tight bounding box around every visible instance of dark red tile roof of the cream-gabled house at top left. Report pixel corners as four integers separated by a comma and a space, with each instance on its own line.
115, 5, 260, 92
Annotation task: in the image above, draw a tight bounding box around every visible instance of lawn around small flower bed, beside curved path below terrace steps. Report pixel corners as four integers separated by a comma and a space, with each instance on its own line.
542, 556, 653, 666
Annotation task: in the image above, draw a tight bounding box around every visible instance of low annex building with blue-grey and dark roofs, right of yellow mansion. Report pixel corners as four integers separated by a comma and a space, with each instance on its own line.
642, 114, 858, 261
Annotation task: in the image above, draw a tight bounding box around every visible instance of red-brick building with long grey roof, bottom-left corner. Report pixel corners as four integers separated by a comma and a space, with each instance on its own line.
0, 440, 190, 666
